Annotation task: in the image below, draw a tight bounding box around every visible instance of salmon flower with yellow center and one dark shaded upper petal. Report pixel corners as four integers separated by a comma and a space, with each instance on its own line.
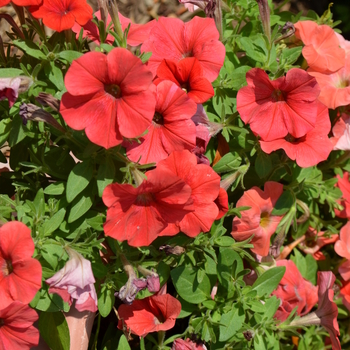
231, 181, 283, 256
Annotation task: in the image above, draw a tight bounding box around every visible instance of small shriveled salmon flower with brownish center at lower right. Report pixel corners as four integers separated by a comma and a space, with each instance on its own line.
299, 227, 339, 260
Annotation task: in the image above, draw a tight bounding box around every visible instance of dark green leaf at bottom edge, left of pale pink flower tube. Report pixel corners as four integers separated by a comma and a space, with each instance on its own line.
38, 312, 70, 350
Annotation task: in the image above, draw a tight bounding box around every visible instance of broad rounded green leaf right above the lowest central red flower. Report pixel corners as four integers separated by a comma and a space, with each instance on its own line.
170, 266, 211, 304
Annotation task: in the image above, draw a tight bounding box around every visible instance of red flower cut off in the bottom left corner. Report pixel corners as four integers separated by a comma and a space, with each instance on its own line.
0, 301, 39, 350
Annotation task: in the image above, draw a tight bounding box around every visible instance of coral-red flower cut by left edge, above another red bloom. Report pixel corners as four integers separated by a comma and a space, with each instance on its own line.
0, 221, 42, 309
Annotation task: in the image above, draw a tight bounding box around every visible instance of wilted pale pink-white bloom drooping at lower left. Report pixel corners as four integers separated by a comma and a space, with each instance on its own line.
45, 248, 97, 312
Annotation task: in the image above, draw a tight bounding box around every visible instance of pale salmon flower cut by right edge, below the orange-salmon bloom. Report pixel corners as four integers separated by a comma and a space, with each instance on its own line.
308, 56, 350, 109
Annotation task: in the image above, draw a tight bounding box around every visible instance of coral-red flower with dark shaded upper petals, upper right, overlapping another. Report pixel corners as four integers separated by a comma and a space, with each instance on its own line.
237, 68, 320, 141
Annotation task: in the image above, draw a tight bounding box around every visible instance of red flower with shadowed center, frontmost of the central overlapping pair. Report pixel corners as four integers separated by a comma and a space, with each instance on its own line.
102, 168, 193, 247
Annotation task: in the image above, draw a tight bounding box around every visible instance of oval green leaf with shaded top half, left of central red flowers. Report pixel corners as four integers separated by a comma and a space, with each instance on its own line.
66, 161, 93, 203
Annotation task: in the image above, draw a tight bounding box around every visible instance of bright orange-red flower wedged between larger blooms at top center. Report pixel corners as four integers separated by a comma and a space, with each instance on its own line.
155, 57, 214, 103
